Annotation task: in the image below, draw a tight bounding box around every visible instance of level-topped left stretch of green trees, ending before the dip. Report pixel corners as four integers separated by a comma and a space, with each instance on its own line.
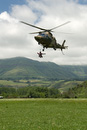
0, 87, 61, 98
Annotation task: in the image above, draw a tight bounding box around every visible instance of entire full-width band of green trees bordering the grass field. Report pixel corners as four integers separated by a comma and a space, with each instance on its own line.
0, 81, 87, 98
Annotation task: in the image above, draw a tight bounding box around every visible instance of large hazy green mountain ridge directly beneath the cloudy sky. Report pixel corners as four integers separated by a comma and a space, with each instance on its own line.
0, 57, 87, 80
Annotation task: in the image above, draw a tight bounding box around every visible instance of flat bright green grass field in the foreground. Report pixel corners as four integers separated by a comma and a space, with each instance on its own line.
0, 99, 87, 130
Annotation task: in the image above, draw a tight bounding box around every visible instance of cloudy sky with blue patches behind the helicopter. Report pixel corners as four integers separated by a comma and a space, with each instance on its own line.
0, 0, 87, 65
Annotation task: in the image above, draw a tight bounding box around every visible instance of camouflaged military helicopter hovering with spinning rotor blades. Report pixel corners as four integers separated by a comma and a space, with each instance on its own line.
20, 21, 70, 51
